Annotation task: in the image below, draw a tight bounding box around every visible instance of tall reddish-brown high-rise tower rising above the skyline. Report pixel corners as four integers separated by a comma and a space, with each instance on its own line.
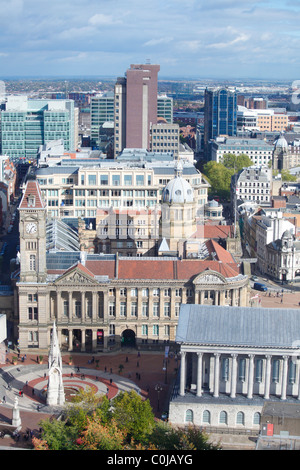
115, 64, 160, 157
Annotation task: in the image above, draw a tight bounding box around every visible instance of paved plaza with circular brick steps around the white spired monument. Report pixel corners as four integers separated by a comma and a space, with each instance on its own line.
0, 350, 178, 449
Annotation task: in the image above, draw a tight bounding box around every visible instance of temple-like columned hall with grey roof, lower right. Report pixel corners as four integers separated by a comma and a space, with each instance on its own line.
170, 305, 300, 429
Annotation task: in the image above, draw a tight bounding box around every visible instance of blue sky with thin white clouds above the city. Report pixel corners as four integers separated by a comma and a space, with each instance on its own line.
0, 0, 300, 81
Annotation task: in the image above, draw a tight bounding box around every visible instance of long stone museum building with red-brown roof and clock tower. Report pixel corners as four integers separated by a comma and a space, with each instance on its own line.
16, 180, 249, 352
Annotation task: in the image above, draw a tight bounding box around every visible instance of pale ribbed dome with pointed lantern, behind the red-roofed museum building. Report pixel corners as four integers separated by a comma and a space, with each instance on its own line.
162, 160, 194, 204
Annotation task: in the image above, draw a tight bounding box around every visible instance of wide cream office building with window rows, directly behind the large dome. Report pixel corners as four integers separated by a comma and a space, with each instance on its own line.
31, 149, 209, 218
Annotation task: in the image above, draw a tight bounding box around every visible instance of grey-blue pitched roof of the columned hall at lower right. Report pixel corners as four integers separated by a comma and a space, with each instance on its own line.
176, 304, 300, 349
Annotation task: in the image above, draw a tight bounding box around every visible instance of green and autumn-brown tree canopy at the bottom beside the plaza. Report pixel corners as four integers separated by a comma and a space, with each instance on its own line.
33, 390, 220, 451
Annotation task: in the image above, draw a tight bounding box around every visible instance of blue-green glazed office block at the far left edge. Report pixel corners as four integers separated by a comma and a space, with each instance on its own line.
1, 96, 78, 160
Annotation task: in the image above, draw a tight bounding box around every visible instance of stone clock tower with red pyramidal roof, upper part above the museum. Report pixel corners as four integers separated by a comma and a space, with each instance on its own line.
19, 180, 47, 282
